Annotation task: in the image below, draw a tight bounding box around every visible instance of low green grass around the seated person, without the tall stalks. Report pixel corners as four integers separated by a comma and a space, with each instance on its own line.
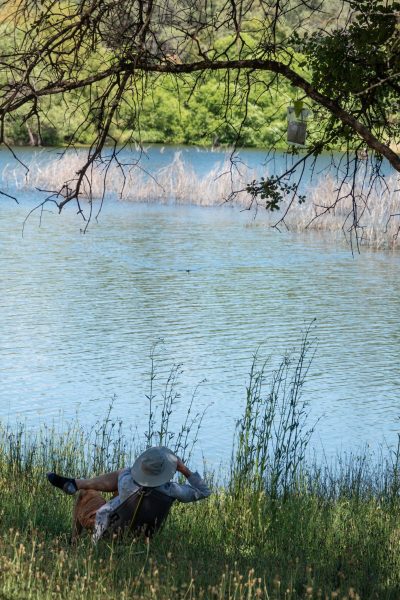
0, 431, 400, 599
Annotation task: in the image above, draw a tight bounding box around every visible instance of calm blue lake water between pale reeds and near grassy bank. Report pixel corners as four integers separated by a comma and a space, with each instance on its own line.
0, 149, 400, 464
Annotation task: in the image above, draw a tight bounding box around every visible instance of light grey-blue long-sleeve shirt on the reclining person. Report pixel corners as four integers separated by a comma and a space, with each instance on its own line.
93, 468, 211, 542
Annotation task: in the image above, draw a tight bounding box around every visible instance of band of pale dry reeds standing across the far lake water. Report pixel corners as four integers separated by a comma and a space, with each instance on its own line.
2, 152, 400, 249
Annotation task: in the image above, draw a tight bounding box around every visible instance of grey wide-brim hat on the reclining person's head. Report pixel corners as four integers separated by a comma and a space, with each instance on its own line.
131, 446, 178, 487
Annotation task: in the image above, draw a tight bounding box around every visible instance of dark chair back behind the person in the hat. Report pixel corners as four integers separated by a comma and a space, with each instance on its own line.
103, 487, 175, 537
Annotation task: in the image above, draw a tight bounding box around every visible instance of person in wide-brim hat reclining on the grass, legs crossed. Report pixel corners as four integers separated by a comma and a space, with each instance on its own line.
47, 446, 211, 542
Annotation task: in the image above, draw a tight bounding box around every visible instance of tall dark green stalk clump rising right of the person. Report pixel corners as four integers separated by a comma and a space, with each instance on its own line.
230, 328, 315, 498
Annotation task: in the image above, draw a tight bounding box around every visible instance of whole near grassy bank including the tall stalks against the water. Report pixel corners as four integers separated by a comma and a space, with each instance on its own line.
0, 336, 400, 600
